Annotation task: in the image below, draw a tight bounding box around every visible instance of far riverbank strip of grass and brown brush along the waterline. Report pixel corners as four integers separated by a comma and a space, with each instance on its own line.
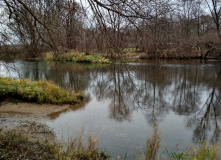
6, 48, 221, 64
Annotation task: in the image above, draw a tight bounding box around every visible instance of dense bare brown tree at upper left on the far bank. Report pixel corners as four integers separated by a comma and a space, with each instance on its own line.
1, 0, 83, 57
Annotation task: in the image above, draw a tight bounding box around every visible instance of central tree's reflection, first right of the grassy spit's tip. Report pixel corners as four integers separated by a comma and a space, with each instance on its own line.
91, 64, 136, 121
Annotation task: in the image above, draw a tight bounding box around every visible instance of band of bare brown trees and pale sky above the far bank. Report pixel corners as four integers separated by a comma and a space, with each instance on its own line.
0, 0, 221, 58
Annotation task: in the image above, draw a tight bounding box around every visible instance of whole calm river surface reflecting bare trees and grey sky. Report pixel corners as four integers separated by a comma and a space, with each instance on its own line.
0, 61, 221, 158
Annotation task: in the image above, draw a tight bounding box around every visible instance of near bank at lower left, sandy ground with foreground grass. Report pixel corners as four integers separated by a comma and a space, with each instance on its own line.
0, 102, 107, 160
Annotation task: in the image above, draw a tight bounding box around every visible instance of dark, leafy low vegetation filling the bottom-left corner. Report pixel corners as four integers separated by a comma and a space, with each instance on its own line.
0, 131, 55, 160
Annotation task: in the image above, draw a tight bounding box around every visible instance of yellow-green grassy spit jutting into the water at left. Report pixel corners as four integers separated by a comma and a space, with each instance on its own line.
0, 77, 83, 104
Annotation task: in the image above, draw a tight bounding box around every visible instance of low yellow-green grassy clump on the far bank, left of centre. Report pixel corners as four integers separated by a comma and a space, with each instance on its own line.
44, 51, 111, 63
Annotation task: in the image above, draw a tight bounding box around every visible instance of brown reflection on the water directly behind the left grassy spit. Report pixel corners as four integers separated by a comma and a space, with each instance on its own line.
20, 62, 90, 91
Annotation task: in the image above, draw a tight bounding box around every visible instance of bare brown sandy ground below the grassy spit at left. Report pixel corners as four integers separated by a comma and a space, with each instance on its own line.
0, 102, 69, 143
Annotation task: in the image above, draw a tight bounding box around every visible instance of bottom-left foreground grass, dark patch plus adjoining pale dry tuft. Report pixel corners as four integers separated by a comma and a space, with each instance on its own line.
0, 131, 109, 160
